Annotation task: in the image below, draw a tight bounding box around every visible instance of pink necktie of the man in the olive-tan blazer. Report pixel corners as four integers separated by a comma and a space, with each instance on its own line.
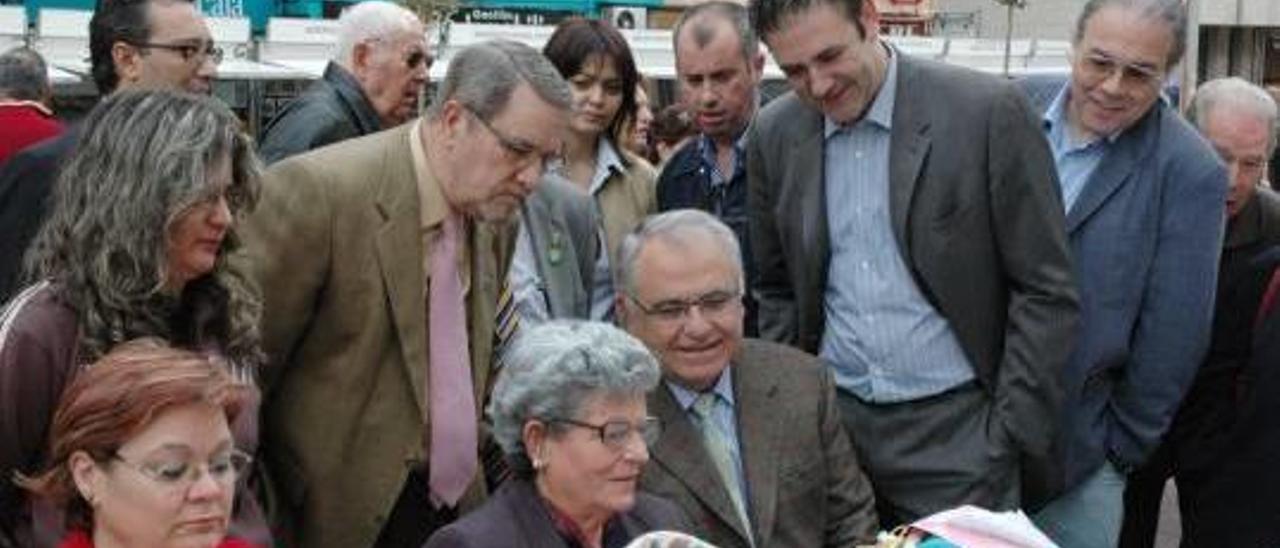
428, 214, 477, 506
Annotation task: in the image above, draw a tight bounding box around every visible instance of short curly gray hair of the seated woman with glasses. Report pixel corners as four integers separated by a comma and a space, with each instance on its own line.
489, 320, 660, 474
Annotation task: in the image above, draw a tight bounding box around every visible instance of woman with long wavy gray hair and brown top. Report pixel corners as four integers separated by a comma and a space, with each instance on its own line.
0, 91, 266, 545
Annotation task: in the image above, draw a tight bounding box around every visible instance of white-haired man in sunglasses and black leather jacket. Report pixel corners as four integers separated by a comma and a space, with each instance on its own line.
259, 0, 433, 164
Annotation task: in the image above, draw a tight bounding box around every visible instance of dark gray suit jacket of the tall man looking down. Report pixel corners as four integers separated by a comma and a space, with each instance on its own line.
748, 52, 1078, 502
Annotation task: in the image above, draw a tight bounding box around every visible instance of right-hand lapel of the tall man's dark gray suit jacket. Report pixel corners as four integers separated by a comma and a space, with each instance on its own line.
888, 51, 932, 257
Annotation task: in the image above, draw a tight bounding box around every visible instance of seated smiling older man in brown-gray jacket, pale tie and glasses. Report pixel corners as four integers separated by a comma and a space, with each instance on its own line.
616, 209, 878, 548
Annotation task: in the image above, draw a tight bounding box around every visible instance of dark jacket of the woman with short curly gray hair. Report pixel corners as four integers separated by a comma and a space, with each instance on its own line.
425, 479, 691, 548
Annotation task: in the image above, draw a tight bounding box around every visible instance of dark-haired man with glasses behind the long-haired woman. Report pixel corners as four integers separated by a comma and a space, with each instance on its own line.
0, 0, 221, 303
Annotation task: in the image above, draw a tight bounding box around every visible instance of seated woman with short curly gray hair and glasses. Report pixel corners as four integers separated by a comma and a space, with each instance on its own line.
426, 320, 689, 548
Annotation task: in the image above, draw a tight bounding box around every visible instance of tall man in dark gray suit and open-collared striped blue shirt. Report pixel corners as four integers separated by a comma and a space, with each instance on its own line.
748, 0, 1078, 526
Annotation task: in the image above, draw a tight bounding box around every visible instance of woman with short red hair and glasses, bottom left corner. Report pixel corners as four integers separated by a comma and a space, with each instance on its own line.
18, 339, 253, 548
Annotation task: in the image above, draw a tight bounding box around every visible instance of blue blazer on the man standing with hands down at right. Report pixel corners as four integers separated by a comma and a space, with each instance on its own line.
1032, 82, 1228, 485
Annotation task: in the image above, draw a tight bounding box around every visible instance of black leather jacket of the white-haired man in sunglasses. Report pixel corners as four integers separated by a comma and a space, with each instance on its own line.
259, 63, 381, 164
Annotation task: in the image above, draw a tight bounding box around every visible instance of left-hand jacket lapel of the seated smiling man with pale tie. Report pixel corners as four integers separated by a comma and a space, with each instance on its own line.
649, 384, 748, 543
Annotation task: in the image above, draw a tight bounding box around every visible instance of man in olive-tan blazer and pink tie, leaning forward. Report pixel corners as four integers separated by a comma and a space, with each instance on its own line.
237, 41, 570, 548
